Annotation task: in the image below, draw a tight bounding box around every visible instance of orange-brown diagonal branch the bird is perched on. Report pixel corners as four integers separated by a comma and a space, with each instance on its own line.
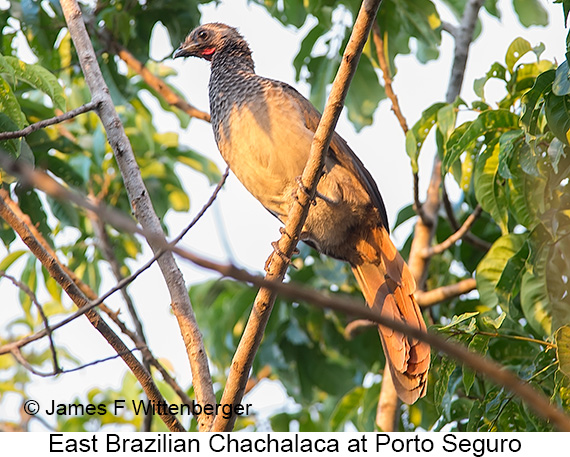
211, 0, 381, 431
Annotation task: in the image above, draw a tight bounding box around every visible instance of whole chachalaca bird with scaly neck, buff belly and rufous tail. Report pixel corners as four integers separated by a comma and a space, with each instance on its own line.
174, 23, 430, 404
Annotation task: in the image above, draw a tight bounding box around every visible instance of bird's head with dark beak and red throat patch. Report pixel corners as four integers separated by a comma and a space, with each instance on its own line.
174, 22, 251, 61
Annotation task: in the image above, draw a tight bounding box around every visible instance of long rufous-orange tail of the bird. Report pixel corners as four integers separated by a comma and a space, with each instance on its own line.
352, 227, 430, 404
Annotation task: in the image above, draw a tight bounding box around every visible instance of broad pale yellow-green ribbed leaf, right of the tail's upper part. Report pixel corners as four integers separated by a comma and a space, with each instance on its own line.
475, 233, 528, 308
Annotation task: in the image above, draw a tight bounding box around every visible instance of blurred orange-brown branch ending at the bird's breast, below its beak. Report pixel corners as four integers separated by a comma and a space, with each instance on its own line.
99, 29, 210, 122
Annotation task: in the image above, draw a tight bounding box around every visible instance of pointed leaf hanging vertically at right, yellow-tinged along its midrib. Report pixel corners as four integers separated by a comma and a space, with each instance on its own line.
473, 143, 508, 234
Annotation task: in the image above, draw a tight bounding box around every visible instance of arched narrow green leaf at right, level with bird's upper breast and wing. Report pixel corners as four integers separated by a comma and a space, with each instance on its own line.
442, 109, 519, 172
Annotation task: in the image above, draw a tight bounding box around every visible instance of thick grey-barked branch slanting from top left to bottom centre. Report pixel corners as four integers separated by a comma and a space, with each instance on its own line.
60, 0, 216, 429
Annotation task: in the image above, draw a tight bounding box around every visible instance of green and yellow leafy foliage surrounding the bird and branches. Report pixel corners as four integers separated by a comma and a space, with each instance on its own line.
0, 0, 570, 431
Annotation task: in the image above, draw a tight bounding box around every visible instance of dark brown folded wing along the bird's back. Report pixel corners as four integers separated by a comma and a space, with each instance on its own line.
274, 81, 390, 233
